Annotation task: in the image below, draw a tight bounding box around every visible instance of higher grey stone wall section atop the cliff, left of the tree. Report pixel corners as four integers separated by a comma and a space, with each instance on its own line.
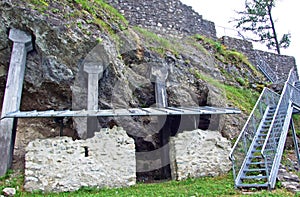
106, 0, 217, 39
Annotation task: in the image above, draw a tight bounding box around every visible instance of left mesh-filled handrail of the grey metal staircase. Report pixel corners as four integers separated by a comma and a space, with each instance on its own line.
229, 88, 279, 179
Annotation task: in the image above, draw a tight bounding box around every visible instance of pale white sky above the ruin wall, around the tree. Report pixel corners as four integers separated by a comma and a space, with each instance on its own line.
181, 0, 300, 66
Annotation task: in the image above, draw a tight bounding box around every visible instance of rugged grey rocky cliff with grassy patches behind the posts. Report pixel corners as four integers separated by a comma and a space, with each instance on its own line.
0, 0, 266, 179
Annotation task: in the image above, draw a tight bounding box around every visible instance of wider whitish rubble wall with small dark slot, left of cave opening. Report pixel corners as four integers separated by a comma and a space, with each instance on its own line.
24, 127, 136, 192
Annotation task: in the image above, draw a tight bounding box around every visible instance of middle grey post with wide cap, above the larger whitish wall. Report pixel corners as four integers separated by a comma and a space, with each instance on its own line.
83, 62, 103, 138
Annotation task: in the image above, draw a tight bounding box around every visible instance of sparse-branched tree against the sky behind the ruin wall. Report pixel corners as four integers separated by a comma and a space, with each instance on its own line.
234, 0, 291, 54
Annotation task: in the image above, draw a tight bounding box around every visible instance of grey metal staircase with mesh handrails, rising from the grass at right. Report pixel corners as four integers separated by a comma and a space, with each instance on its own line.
230, 69, 300, 189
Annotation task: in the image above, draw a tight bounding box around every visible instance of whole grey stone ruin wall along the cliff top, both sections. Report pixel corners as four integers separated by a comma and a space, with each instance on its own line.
106, 0, 297, 80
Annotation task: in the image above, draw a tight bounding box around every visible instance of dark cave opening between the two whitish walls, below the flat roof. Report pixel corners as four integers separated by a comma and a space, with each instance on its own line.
133, 114, 211, 183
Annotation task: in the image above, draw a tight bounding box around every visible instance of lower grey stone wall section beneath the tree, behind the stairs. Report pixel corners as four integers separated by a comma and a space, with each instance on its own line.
221, 36, 297, 81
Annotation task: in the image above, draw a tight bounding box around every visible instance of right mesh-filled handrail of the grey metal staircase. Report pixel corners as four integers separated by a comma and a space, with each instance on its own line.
261, 68, 296, 187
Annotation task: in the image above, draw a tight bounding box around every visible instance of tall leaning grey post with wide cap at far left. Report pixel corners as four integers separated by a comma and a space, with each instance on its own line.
0, 29, 33, 176
